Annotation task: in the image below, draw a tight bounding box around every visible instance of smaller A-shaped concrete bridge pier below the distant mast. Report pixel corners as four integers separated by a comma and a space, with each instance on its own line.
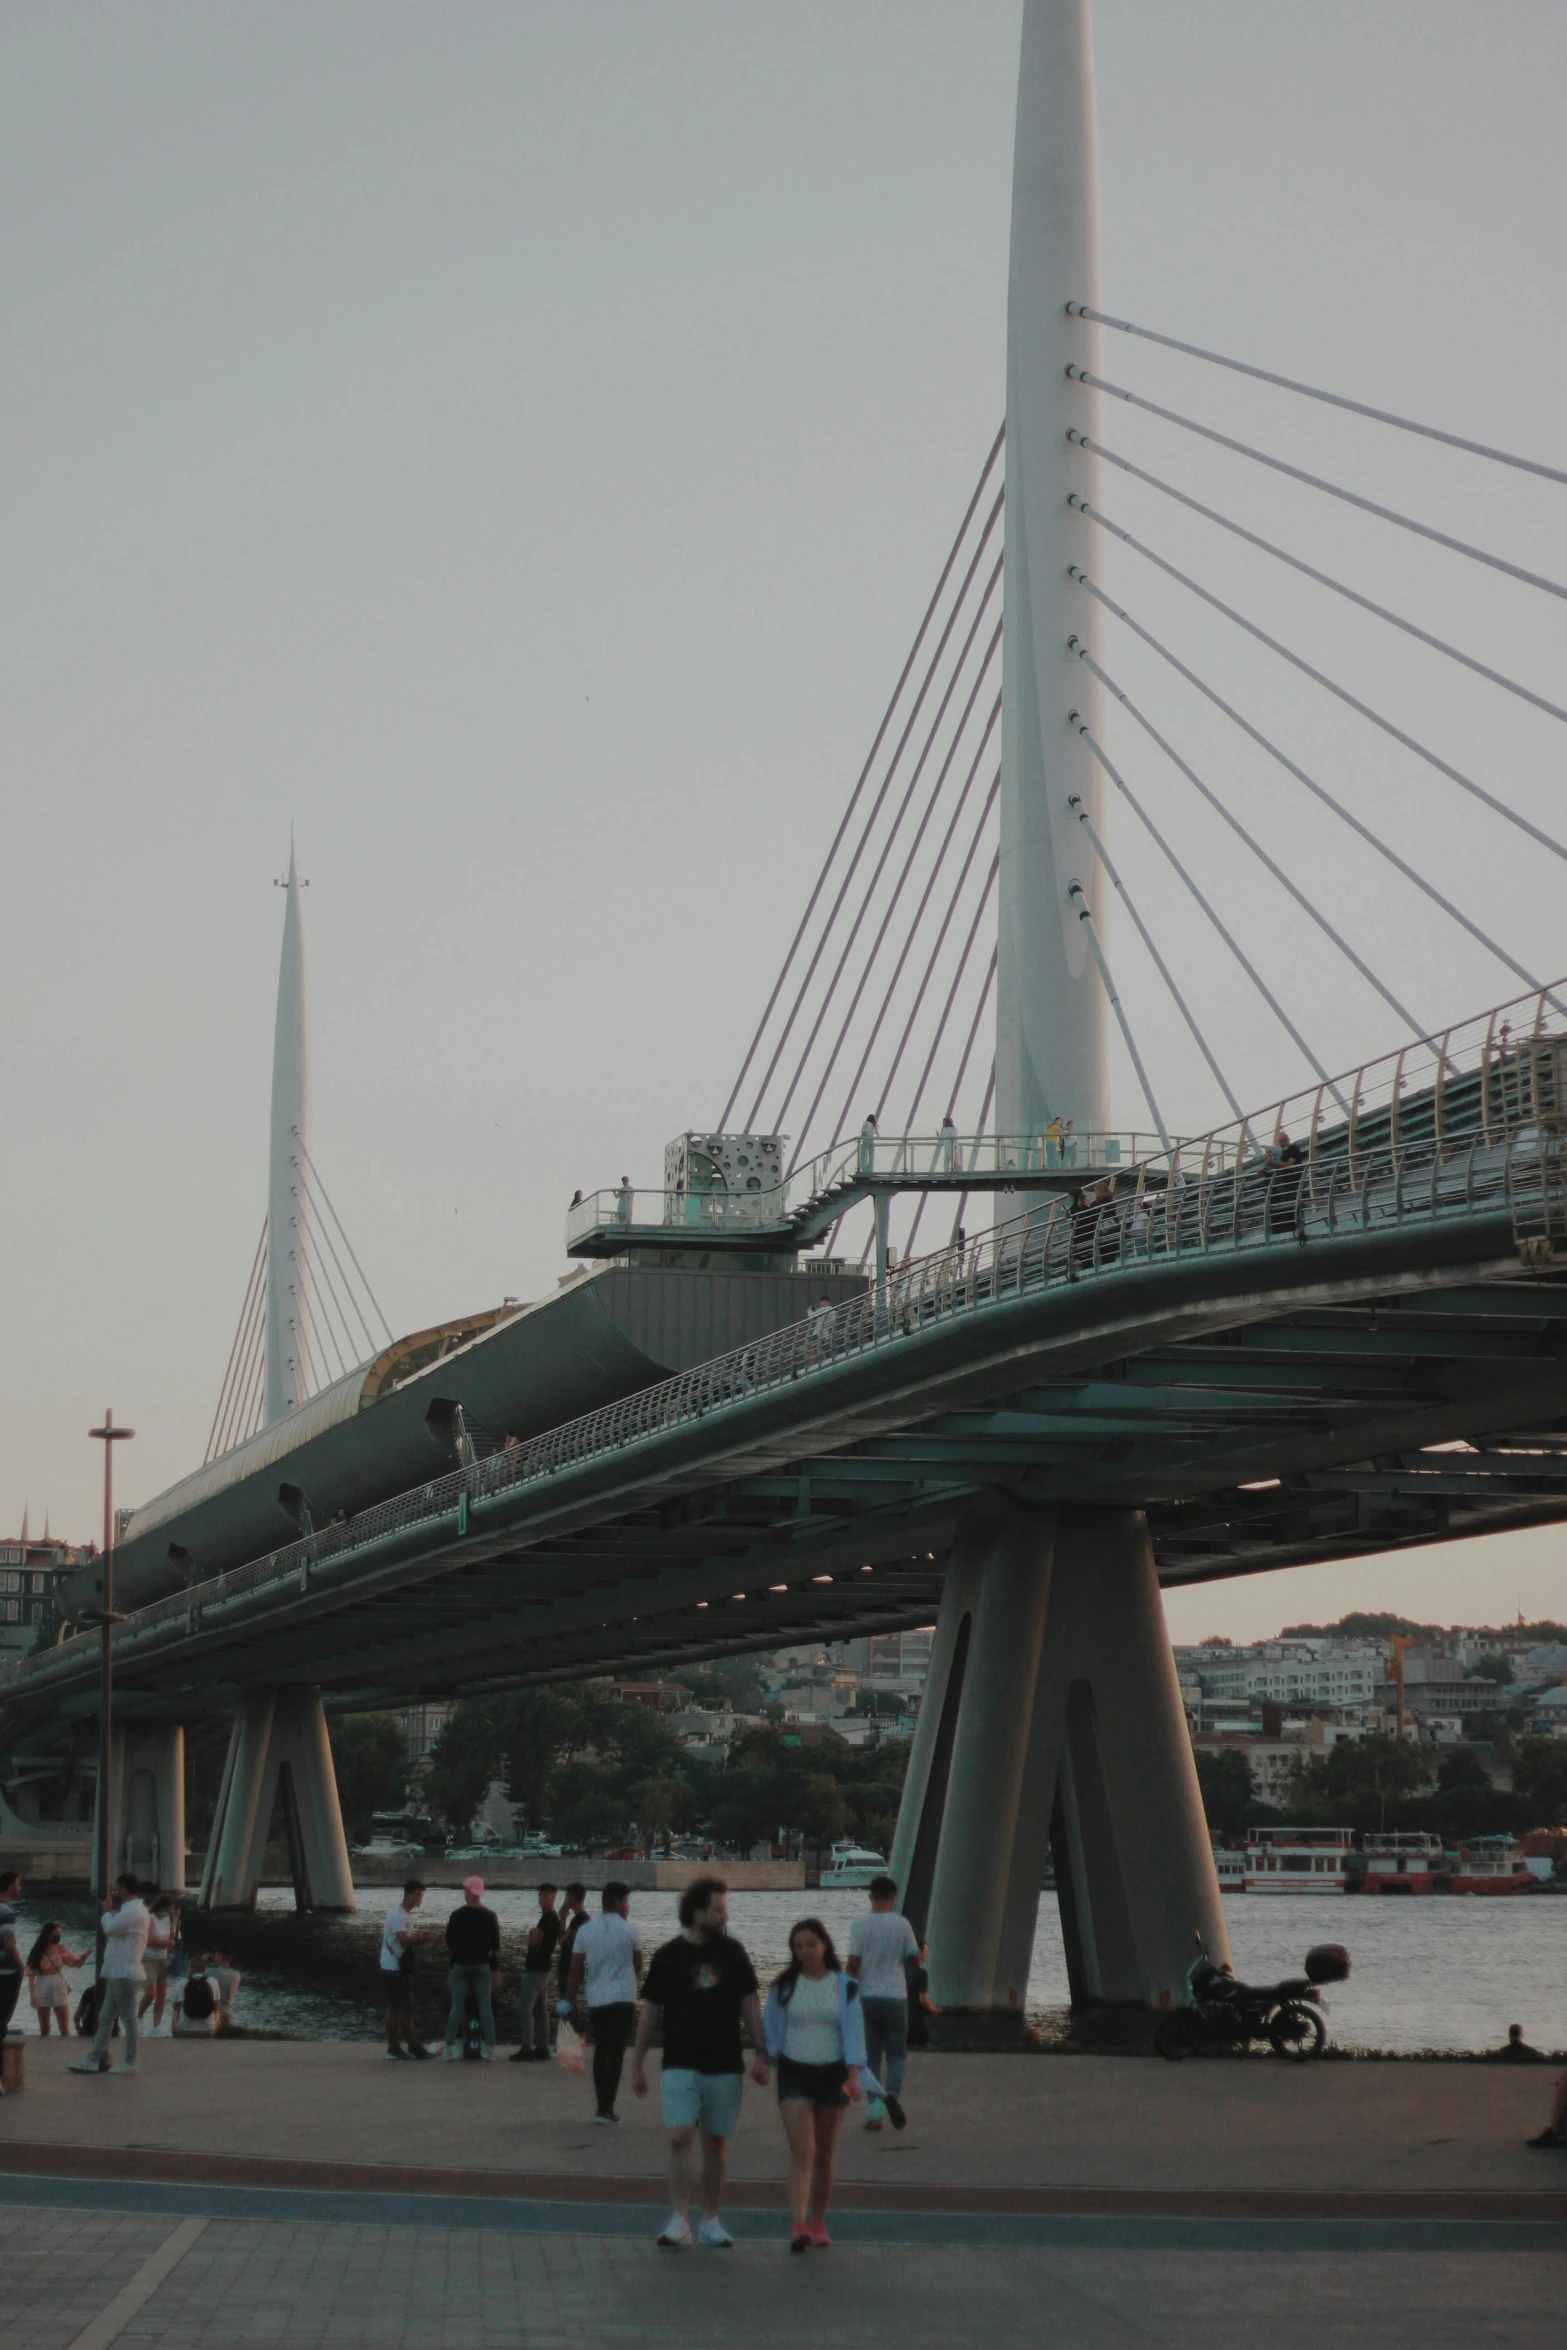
202, 1683, 355, 1911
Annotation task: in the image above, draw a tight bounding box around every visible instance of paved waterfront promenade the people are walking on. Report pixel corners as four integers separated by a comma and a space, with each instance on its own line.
0, 2040, 1567, 2350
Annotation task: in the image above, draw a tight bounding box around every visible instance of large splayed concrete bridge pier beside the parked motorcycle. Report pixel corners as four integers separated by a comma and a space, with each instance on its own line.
893, 1509, 1229, 2033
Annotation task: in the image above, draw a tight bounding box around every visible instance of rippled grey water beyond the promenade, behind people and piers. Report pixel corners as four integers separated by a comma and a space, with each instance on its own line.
16, 1885, 1567, 2052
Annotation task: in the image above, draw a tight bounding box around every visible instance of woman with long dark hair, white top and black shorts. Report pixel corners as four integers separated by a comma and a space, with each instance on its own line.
761, 1918, 865, 2251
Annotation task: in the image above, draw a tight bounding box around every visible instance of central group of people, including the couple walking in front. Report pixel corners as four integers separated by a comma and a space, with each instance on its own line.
381, 1875, 923, 2251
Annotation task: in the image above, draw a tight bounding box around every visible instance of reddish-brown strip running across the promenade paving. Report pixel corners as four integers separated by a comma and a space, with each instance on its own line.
0, 2143, 1567, 2223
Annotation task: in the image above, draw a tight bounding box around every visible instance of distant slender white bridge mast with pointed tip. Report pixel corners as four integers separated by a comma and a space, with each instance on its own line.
265, 837, 320, 1422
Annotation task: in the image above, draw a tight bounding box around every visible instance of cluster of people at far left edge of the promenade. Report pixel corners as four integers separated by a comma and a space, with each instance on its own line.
0, 1871, 240, 2073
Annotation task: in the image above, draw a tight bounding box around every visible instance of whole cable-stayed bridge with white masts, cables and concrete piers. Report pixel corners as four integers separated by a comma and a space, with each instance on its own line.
12, 0, 1567, 2019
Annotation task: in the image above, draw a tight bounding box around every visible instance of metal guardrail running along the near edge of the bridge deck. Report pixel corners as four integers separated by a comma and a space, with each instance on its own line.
0, 1119, 1567, 1694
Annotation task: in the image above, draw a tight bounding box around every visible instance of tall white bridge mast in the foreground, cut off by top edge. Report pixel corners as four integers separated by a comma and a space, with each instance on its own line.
996, 0, 1109, 1135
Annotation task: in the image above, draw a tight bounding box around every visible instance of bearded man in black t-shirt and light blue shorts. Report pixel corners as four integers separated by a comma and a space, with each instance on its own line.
632, 1878, 771, 2249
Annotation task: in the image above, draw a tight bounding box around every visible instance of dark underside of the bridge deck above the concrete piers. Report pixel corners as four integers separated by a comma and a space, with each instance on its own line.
7, 1276, 1567, 1746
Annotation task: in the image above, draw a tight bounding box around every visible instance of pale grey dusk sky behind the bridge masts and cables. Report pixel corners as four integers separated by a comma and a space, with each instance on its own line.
0, 0, 1567, 1636
